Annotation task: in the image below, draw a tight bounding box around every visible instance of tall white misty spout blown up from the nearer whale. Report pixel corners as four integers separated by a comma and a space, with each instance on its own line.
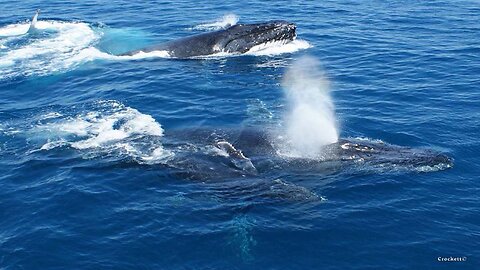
282, 57, 339, 158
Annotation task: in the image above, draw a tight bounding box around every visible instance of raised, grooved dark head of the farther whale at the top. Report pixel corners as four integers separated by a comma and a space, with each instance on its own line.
219, 21, 297, 53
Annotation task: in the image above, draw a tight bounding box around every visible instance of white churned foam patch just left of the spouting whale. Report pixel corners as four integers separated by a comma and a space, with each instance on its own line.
35, 101, 171, 163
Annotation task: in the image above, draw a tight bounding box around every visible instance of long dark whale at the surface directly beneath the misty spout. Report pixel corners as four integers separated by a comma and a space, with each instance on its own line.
163, 128, 453, 181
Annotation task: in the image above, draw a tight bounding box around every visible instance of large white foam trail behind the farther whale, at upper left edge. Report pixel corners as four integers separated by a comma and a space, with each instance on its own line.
0, 21, 176, 79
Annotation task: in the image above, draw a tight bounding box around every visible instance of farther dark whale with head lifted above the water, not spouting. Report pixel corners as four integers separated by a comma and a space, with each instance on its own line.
124, 21, 296, 58
